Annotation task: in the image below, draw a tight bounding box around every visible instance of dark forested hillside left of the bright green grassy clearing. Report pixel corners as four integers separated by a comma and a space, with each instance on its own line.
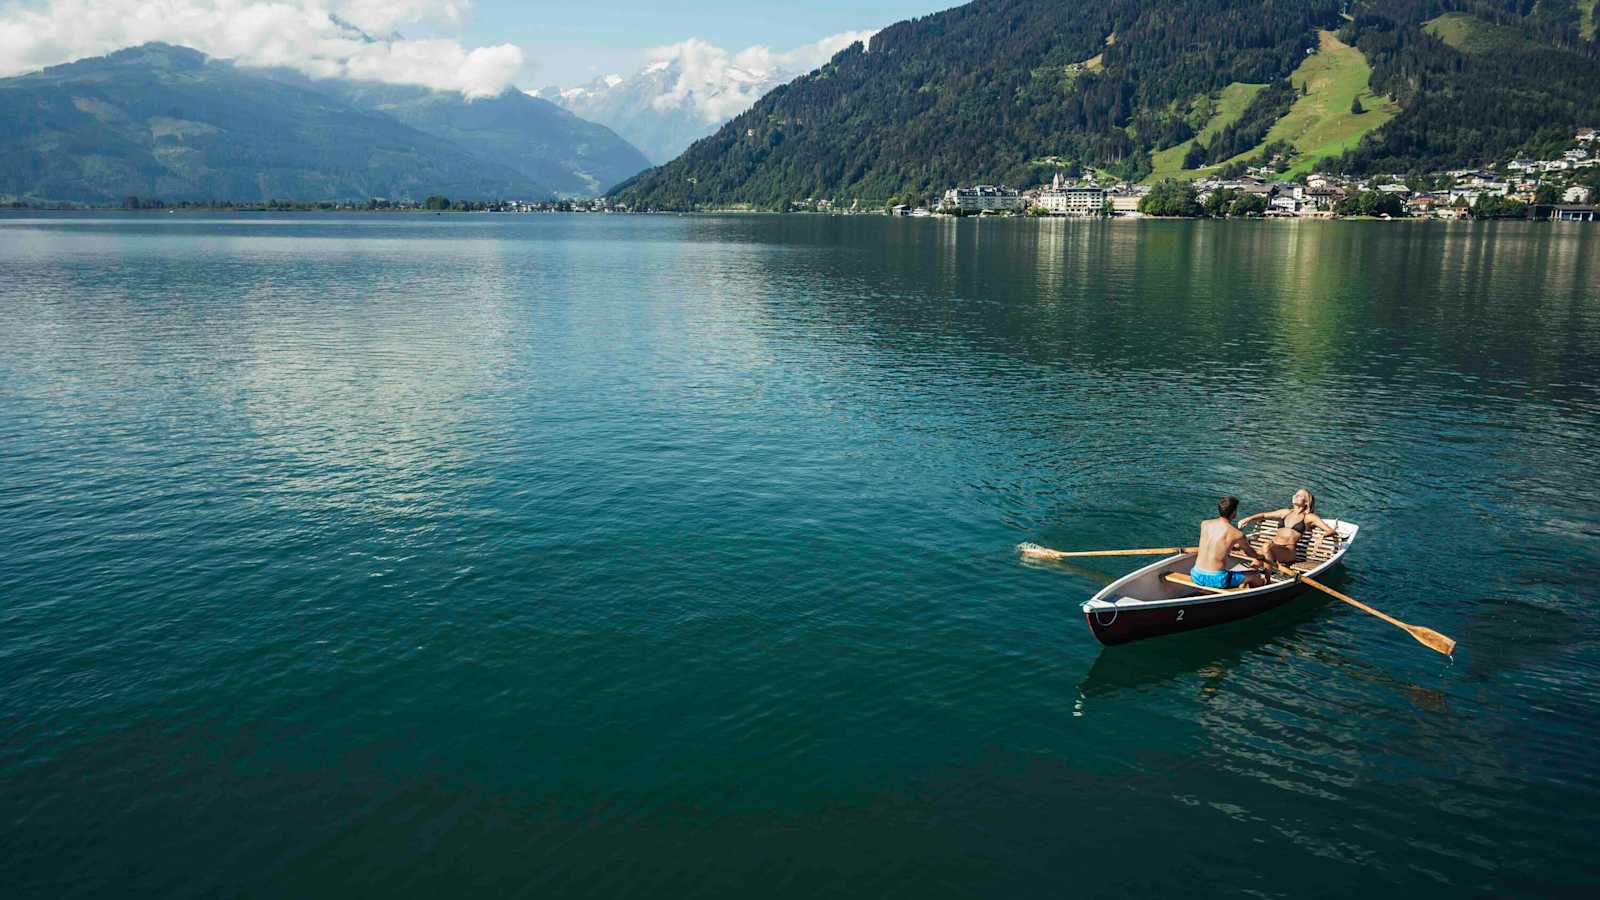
613, 0, 1342, 208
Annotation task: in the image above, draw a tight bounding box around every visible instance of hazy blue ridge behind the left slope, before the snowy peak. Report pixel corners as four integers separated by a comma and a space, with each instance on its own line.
320, 82, 650, 197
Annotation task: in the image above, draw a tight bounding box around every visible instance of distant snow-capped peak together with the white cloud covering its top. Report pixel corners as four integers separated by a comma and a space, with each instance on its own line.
531, 30, 874, 165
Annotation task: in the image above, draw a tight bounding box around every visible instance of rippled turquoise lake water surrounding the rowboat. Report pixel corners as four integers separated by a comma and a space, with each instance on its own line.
0, 215, 1600, 898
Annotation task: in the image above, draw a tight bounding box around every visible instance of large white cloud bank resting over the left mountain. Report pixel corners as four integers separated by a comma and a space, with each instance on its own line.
0, 0, 523, 98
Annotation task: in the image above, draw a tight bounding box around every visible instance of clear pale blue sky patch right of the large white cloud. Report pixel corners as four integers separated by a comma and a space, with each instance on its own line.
461, 0, 940, 86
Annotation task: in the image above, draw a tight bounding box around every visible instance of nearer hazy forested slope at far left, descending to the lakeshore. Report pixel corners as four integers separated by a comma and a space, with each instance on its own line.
0, 45, 554, 202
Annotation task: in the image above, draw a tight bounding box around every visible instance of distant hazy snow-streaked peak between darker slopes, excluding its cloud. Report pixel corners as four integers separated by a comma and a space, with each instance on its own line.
534, 58, 800, 164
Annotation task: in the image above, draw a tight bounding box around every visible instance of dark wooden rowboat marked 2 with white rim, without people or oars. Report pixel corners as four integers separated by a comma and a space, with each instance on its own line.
1083, 519, 1360, 645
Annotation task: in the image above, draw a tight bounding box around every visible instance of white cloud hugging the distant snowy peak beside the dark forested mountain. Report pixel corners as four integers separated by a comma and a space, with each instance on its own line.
645, 30, 877, 122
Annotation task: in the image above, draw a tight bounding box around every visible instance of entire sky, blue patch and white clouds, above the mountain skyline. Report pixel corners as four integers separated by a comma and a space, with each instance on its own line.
0, 0, 954, 90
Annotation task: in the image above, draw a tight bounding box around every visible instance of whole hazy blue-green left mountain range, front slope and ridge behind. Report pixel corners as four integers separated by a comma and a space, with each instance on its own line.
0, 43, 645, 202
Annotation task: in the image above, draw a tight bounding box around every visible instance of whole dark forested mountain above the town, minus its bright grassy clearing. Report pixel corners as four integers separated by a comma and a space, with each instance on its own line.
613, 0, 1600, 208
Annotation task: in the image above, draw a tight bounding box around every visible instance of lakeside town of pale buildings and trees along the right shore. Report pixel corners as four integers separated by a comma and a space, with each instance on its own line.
902, 128, 1600, 223
